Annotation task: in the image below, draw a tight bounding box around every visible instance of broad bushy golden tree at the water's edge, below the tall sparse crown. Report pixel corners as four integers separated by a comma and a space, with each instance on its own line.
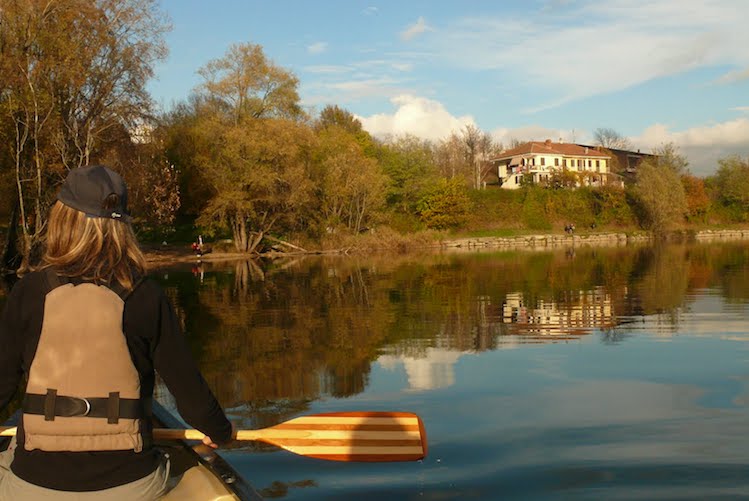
196, 118, 314, 252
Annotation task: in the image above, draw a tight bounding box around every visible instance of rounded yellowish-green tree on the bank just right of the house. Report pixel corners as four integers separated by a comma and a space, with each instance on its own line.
634, 145, 687, 234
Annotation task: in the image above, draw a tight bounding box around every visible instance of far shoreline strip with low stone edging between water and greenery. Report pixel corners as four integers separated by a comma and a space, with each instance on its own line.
143, 228, 749, 265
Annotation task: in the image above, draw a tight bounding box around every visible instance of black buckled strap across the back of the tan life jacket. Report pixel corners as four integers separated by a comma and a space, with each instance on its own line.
22, 389, 151, 424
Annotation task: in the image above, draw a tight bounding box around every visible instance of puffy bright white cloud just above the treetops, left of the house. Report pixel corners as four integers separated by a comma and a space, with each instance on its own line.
359, 94, 475, 141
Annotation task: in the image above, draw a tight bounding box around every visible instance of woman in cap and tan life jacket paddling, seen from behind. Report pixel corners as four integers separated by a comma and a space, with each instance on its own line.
0, 166, 232, 500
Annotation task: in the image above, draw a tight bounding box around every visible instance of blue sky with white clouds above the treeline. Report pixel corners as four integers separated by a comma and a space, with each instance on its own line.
148, 0, 749, 176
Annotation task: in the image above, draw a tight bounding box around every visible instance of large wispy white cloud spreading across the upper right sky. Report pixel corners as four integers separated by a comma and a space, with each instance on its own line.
429, 0, 749, 109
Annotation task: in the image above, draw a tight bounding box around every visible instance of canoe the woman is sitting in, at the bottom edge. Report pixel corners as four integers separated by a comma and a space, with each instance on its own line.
0, 402, 263, 501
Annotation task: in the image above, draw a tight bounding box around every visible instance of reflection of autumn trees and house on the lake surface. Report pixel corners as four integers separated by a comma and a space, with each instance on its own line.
150, 243, 749, 410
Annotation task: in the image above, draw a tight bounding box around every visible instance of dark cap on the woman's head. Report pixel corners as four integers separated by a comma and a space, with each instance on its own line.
57, 165, 132, 223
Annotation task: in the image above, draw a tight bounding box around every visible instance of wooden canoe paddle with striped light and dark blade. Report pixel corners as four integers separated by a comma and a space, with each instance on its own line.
0, 412, 427, 462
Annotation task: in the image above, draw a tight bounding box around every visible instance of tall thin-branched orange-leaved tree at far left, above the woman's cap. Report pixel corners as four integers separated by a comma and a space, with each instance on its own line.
0, 0, 168, 266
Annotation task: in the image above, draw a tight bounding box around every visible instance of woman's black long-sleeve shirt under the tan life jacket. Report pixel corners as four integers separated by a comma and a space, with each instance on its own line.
0, 272, 231, 491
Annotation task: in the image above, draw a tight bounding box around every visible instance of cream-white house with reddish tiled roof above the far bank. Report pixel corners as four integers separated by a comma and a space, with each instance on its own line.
492, 139, 611, 190
